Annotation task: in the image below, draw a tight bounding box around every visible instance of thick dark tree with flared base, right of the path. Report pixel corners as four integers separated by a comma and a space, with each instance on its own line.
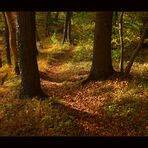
85, 12, 115, 82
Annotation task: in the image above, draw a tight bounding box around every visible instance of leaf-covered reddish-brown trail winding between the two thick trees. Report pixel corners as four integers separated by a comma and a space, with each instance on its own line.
40, 45, 147, 136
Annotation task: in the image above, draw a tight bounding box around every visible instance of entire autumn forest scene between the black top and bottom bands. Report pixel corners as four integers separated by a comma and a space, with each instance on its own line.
0, 11, 148, 136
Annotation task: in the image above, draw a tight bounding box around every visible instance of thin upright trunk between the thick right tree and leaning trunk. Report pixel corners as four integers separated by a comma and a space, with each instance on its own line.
119, 12, 124, 74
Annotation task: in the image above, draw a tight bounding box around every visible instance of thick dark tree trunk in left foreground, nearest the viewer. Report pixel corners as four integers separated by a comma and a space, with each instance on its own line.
17, 12, 45, 98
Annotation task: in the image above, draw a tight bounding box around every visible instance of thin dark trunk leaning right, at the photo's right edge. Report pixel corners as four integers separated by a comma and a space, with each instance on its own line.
125, 22, 148, 75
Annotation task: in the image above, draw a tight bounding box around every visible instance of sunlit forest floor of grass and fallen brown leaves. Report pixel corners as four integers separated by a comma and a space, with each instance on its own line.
0, 37, 148, 136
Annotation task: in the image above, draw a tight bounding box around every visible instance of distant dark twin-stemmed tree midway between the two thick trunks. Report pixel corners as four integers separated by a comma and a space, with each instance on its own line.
62, 12, 72, 44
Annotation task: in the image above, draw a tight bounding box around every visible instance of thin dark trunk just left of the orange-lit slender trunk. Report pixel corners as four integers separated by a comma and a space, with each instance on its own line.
2, 13, 11, 65
